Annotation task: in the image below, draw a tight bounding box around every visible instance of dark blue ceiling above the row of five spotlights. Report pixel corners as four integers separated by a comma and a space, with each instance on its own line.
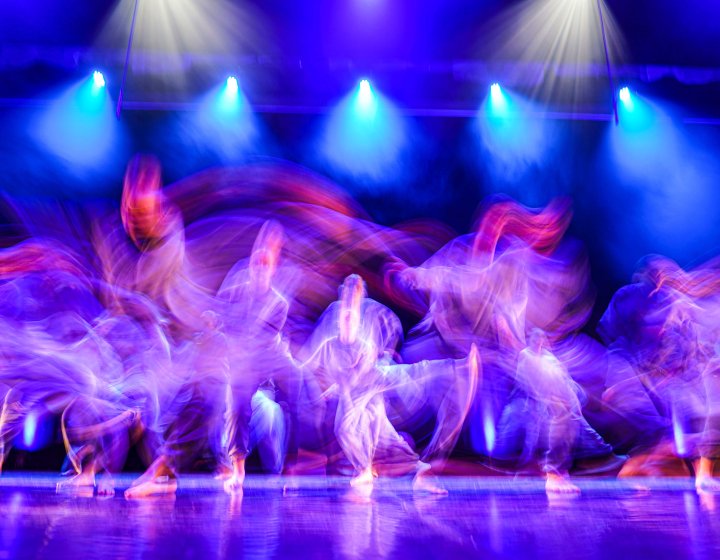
0, 0, 720, 114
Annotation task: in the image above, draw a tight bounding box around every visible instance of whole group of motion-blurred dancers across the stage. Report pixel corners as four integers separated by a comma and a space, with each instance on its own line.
0, 156, 720, 498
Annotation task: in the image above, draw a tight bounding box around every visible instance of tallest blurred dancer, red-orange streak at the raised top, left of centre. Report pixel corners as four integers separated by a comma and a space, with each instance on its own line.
116, 156, 226, 498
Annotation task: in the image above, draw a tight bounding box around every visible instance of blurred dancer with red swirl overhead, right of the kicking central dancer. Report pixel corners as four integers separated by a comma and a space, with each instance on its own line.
386, 199, 606, 474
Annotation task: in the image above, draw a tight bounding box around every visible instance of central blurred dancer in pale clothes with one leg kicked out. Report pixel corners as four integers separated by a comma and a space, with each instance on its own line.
305, 275, 478, 493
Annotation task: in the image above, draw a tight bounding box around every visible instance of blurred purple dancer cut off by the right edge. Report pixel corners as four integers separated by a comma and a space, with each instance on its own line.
598, 256, 720, 492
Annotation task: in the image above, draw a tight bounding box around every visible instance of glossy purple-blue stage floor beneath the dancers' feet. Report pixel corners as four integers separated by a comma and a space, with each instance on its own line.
0, 473, 720, 560
